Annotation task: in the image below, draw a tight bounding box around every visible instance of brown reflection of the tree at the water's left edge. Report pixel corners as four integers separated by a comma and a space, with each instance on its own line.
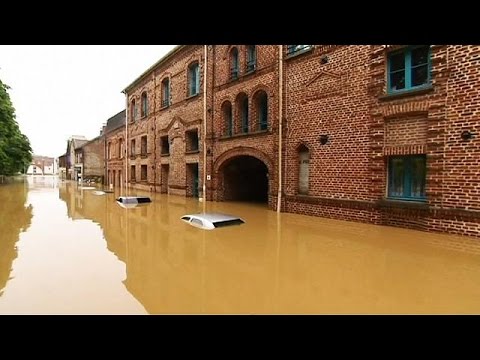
0, 181, 33, 296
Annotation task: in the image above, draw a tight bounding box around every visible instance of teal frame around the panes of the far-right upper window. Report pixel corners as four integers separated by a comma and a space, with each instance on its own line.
387, 45, 432, 94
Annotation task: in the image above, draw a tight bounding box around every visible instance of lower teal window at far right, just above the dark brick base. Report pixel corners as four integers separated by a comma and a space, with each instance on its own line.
388, 155, 426, 200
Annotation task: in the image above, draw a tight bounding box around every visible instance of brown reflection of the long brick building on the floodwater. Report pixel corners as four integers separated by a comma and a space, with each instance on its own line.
59, 183, 480, 314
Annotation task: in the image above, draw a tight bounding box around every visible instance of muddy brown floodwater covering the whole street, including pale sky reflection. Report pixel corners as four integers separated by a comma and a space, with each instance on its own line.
0, 176, 480, 314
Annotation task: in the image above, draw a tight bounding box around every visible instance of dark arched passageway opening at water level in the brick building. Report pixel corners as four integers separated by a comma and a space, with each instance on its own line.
221, 155, 268, 203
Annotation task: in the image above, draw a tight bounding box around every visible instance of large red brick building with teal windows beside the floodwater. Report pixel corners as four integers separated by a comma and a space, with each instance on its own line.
125, 45, 480, 236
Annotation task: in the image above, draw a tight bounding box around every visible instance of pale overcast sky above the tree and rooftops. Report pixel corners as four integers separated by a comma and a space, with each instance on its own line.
0, 45, 175, 157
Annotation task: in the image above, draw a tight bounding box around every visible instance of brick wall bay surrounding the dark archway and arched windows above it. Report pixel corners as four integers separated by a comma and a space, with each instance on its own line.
211, 45, 278, 208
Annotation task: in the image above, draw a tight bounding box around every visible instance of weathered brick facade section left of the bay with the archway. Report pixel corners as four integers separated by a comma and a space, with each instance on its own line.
125, 45, 204, 196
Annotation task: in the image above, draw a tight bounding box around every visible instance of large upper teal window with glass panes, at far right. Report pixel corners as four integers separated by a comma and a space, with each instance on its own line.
387, 46, 430, 93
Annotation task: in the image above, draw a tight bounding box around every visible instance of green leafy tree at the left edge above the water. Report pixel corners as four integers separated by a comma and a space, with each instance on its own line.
0, 80, 32, 175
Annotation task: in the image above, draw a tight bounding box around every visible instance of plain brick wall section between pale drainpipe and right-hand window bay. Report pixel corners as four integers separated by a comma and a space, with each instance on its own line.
285, 46, 372, 204
